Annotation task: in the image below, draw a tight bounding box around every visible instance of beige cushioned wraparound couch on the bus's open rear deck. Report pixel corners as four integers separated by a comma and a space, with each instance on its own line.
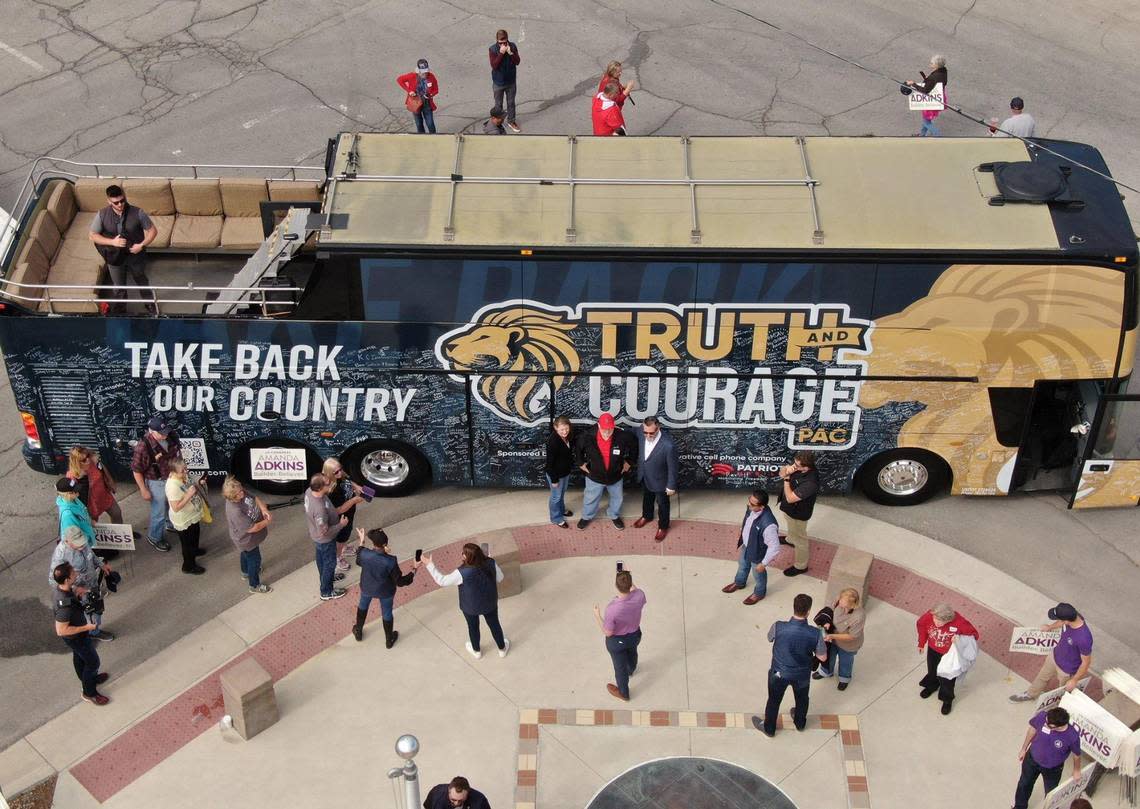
7, 177, 321, 312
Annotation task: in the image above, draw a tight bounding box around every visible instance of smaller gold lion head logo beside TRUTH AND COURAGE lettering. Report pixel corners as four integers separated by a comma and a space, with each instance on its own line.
442, 307, 580, 422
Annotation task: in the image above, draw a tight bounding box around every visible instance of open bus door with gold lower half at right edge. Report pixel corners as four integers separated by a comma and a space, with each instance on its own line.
1069, 393, 1140, 508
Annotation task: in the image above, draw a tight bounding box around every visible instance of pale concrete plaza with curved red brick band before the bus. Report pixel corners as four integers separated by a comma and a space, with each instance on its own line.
0, 492, 1140, 809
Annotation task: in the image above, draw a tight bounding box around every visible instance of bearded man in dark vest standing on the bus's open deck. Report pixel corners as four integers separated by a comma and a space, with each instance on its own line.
88, 186, 158, 314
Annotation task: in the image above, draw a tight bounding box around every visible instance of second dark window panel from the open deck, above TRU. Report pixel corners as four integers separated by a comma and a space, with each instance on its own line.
522, 261, 697, 307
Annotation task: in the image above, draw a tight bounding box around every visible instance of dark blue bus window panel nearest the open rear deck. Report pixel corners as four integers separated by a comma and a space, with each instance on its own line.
360, 259, 521, 324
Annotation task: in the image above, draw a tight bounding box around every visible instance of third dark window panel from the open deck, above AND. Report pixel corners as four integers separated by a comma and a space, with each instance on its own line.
697, 262, 874, 317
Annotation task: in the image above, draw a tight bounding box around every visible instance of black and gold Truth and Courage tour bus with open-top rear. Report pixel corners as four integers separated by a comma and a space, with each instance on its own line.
0, 132, 1140, 507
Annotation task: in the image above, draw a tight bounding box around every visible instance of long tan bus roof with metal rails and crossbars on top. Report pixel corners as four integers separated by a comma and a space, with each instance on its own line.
321, 133, 1135, 254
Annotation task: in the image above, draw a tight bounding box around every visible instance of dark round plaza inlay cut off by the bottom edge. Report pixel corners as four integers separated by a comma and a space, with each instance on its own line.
586, 757, 796, 809
